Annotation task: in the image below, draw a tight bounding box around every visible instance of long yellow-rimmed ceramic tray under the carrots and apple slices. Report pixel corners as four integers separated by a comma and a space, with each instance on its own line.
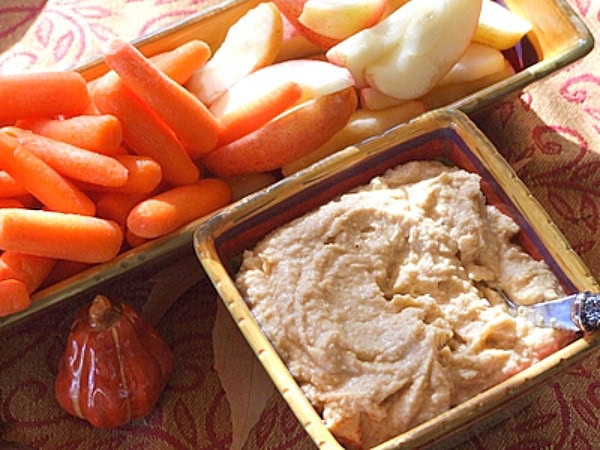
0, 0, 594, 331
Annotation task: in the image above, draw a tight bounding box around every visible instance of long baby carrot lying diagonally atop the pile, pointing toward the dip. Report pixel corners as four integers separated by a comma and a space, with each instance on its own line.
103, 39, 218, 158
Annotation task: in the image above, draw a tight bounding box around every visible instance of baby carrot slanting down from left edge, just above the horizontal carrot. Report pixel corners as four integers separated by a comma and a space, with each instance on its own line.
0, 131, 96, 216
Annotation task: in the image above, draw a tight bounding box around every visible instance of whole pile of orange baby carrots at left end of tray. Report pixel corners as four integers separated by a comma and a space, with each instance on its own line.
0, 40, 237, 316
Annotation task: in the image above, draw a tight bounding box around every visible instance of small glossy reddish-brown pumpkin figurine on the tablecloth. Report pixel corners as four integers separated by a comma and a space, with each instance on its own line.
54, 295, 173, 428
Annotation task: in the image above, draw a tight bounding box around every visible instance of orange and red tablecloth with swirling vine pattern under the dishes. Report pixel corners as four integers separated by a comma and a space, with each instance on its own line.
0, 0, 600, 450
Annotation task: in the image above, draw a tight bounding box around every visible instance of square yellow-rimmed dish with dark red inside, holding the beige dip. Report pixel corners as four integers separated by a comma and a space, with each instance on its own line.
194, 110, 600, 449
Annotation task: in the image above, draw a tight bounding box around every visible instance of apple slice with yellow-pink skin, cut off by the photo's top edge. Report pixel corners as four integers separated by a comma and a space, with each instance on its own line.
298, 0, 388, 40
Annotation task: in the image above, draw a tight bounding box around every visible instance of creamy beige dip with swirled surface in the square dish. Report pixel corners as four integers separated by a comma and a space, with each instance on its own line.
236, 161, 570, 447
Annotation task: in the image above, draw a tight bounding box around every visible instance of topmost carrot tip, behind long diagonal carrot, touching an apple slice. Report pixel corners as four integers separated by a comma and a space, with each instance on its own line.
150, 39, 211, 84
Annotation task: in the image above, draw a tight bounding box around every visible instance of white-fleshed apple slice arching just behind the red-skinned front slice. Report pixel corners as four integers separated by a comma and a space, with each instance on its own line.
210, 59, 354, 117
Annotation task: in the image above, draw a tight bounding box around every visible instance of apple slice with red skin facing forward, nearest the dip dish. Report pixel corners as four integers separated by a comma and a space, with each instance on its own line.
201, 87, 358, 177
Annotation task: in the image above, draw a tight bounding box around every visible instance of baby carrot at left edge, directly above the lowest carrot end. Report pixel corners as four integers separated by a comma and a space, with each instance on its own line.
0, 252, 56, 294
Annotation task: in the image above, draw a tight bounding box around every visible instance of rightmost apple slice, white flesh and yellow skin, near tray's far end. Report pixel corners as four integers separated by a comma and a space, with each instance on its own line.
473, 0, 533, 50
